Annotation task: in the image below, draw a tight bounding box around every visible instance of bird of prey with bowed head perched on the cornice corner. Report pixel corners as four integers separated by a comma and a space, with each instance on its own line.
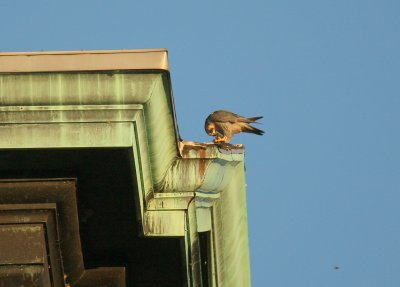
205, 110, 264, 143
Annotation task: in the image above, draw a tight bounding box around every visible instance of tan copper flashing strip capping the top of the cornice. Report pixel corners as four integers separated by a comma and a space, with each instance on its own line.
0, 49, 169, 73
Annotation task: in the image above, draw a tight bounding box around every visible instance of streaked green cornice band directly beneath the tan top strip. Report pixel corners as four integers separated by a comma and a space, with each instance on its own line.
0, 72, 161, 106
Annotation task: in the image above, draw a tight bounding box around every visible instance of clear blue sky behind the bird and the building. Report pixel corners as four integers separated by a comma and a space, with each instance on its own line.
0, 0, 400, 287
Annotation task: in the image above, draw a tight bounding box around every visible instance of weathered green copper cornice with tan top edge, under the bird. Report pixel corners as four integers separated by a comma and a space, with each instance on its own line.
0, 49, 250, 286
